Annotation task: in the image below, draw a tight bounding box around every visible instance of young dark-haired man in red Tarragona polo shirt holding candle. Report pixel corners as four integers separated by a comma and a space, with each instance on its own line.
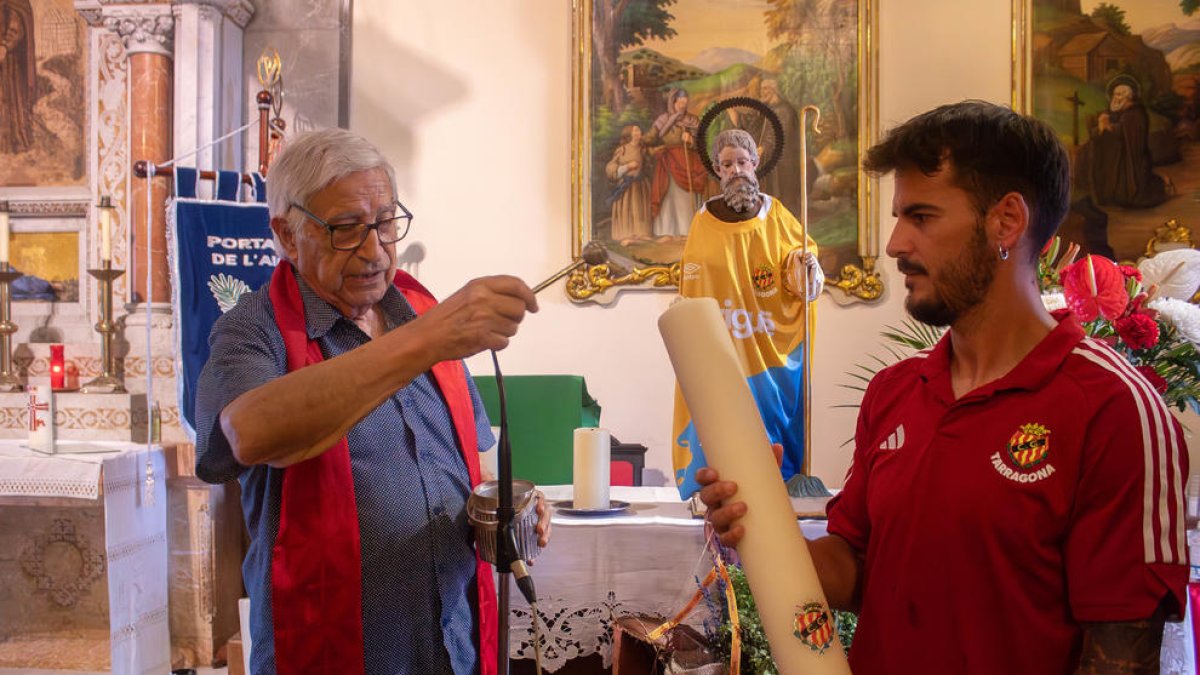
697, 101, 1188, 675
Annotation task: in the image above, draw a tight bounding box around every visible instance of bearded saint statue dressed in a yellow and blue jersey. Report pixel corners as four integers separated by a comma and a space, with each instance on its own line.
672, 129, 824, 497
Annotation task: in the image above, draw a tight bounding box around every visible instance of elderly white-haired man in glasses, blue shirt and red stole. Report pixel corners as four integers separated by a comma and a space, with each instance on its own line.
197, 129, 548, 675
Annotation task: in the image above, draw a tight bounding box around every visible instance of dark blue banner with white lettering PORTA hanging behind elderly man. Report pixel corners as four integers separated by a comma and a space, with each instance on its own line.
170, 171, 278, 432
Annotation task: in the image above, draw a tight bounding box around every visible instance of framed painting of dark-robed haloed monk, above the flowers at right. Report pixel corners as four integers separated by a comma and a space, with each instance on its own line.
1013, 0, 1200, 262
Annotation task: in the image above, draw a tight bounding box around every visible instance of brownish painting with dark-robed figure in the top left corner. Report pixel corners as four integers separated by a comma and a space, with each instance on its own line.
0, 0, 88, 189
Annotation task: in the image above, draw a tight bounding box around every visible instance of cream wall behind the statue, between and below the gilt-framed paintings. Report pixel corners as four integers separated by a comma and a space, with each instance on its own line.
350, 0, 1012, 485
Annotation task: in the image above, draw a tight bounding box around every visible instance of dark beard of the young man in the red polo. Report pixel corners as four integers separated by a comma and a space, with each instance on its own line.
896, 219, 1000, 327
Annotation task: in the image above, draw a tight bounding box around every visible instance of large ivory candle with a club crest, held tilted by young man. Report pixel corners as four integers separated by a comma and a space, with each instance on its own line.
659, 298, 850, 675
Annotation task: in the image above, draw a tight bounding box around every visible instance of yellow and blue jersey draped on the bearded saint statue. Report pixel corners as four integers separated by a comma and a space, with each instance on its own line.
672, 195, 817, 498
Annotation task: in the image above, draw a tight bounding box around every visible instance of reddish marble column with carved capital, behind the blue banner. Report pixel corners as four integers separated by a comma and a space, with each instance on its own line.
103, 4, 175, 307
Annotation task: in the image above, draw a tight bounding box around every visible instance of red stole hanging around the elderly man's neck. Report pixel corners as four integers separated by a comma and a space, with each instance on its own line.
269, 261, 498, 675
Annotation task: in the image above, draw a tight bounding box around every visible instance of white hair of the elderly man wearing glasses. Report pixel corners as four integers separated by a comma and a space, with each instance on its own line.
266, 127, 396, 258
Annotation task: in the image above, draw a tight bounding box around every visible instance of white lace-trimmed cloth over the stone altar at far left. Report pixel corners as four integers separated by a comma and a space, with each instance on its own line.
0, 441, 170, 675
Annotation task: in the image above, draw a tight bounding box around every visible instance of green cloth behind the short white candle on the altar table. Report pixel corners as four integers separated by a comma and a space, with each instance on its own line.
474, 375, 600, 485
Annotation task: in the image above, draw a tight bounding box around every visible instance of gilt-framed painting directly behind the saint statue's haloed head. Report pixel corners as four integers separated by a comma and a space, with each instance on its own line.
566, 0, 883, 303
